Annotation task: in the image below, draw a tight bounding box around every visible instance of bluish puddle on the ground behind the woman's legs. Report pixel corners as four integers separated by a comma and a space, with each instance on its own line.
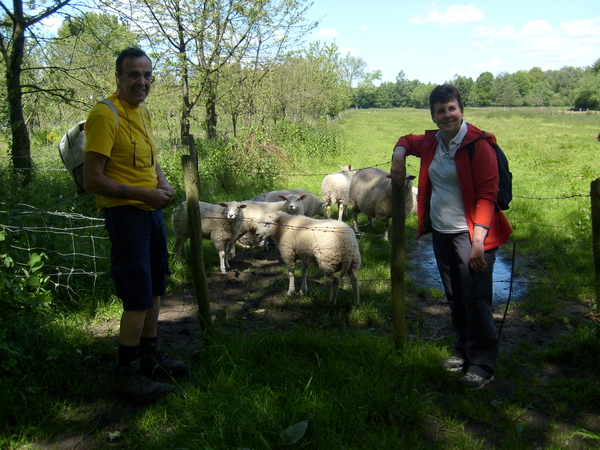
406, 234, 527, 305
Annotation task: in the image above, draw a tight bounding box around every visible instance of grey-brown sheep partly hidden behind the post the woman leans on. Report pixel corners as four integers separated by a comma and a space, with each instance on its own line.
348, 167, 415, 241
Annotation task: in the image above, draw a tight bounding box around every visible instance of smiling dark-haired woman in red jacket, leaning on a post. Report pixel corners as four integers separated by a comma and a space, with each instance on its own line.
390, 84, 512, 389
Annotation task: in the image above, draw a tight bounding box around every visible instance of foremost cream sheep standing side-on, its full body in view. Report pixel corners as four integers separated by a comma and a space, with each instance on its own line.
256, 211, 361, 306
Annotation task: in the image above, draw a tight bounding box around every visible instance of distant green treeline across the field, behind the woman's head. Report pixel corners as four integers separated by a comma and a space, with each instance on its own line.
354, 59, 600, 109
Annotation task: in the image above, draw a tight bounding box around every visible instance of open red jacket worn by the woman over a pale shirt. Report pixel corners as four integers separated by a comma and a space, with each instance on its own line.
396, 124, 513, 250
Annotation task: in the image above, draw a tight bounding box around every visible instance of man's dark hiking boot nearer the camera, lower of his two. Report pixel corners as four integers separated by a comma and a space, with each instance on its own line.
114, 361, 169, 402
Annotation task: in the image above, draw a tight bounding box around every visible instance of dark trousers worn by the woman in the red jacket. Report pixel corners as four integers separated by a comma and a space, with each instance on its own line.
433, 231, 498, 378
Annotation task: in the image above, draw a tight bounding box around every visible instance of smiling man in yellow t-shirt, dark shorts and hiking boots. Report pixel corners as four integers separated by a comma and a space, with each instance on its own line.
84, 48, 187, 401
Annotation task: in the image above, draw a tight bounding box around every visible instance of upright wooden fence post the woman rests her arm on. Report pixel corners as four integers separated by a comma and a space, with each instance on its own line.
390, 181, 406, 349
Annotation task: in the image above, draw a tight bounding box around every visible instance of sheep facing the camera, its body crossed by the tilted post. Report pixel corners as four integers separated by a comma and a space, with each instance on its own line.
171, 201, 246, 275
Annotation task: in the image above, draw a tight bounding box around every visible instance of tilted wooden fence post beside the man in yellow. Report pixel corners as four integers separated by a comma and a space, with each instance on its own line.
181, 155, 212, 332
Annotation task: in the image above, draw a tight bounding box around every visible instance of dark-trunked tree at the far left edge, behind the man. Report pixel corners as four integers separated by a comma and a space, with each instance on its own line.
0, 0, 70, 184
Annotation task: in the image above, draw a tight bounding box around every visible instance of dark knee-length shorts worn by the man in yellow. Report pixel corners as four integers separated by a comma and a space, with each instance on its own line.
104, 206, 169, 311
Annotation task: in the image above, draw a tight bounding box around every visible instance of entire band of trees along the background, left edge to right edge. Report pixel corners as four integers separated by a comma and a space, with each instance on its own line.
0, 0, 600, 177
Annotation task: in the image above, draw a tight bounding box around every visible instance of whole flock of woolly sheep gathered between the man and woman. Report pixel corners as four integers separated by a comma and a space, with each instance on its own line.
172, 166, 416, 306
